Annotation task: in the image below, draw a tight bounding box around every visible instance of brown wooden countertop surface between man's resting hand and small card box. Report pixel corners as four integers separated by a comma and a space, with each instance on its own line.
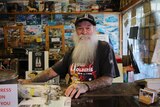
82, 83, 140, 98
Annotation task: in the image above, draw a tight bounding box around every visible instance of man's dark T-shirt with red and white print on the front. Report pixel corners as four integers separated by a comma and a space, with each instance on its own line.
52, 41, 120, 81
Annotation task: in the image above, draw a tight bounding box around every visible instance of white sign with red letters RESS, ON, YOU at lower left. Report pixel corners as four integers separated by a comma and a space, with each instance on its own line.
0, 84, 18, 107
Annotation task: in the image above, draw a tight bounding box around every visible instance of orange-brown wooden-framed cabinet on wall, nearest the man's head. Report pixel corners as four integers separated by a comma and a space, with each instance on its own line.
45, 25, 65, 59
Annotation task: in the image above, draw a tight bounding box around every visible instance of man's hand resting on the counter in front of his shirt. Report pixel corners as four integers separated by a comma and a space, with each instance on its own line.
65, 83, 88, 98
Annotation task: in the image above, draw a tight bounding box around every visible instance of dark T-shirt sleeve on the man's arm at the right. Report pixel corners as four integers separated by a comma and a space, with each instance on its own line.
99, 43, 120, 78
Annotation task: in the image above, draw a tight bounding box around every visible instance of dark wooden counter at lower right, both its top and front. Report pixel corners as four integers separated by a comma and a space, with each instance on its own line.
72, 83, 160, 107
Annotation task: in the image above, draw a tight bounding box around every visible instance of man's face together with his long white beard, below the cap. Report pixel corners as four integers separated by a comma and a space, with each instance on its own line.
72, 21, 98, 64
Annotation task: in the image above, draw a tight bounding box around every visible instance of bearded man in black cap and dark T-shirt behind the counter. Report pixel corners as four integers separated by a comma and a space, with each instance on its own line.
19, 14, 119, 98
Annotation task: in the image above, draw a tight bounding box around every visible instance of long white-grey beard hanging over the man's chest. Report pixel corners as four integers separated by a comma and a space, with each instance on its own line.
72, 35, 98, 64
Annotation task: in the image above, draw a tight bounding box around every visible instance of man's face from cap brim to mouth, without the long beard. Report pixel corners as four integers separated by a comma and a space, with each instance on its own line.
76, 21, 95, 40
